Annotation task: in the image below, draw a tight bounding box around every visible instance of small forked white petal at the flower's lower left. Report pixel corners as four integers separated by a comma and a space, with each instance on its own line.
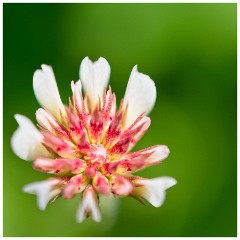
23, 179, 61, 210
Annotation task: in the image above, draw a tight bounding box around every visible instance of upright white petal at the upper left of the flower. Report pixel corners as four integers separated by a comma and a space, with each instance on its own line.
33, 64, 65, 120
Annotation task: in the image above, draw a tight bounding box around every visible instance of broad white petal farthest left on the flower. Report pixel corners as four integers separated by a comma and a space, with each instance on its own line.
11, 114, 51, 160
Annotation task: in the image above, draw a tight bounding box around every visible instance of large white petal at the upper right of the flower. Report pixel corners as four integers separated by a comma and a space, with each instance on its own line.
124, 66, 157, 128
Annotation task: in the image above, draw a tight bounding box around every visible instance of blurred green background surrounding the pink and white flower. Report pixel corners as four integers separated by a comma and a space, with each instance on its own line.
3, 4, 237, 236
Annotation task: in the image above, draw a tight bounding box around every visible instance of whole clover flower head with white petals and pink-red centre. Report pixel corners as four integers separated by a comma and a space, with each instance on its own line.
11, 57, 176, 222
